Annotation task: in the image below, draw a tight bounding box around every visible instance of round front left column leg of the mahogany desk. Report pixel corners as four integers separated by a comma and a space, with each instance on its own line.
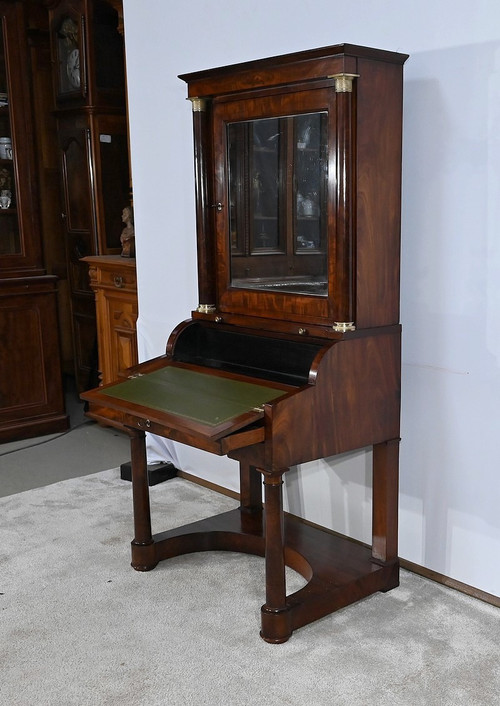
130, 431, 158, 571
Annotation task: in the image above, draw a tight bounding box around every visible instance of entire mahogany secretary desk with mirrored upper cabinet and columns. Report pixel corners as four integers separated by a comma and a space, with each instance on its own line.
84, 44, 407, 643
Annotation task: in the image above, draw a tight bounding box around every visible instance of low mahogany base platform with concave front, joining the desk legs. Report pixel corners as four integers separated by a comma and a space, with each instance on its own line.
132, 508, 399, 643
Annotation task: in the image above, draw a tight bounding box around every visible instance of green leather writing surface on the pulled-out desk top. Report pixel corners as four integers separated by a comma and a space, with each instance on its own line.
103, 366, 284, 426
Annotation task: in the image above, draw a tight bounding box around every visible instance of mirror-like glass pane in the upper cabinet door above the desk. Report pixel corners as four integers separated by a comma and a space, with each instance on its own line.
227, 112, 328, 296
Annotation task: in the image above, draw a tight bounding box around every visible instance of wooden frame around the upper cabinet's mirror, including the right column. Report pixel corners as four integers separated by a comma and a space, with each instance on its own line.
212, 82, 354, 324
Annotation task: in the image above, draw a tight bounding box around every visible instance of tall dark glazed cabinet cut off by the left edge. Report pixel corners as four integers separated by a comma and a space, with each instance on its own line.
0, 2, 68, 441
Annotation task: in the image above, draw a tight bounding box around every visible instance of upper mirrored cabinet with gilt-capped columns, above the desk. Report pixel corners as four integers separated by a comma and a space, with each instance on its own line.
181, 44, 407, 337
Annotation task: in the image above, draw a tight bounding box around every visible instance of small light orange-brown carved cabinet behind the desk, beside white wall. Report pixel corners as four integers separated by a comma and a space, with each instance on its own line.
84, 255, 138, 385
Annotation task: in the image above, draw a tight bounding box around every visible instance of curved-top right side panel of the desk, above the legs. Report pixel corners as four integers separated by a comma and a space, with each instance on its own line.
266, 332, 401, 471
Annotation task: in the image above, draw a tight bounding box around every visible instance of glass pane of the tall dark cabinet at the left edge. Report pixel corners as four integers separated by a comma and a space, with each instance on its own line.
0, 31, 21, 255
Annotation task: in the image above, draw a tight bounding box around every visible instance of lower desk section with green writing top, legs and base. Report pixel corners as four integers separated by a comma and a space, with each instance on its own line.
83, 321, 399, 642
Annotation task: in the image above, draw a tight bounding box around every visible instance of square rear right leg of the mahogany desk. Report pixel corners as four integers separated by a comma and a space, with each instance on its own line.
372, 439, 399, 563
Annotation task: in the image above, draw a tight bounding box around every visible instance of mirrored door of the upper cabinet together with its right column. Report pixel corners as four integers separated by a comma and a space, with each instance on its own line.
213, 82, 353, 324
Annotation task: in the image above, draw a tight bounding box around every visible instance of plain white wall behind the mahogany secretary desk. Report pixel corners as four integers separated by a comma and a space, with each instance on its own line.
124, 0, 500, 595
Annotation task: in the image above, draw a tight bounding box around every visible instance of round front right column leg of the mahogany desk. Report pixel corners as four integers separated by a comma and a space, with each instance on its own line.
260, 474, 292, 643
